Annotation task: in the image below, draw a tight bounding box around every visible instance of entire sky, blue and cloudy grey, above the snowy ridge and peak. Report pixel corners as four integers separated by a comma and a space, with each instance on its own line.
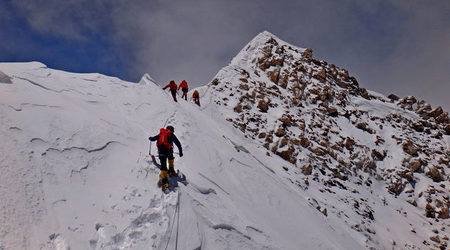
0, 0, 450, 110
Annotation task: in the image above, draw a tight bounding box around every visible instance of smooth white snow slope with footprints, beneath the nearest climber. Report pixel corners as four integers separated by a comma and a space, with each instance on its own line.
0, 63, 366, 249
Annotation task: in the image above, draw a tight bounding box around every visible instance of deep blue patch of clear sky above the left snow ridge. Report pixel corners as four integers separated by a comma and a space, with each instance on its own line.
0, 1, 128, 79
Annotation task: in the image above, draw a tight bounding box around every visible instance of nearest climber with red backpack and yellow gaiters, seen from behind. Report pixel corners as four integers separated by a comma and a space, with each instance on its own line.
148, 126, 183, 186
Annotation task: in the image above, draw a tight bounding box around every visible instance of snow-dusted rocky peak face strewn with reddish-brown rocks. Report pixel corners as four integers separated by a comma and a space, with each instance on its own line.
201, 32, 450, 249
